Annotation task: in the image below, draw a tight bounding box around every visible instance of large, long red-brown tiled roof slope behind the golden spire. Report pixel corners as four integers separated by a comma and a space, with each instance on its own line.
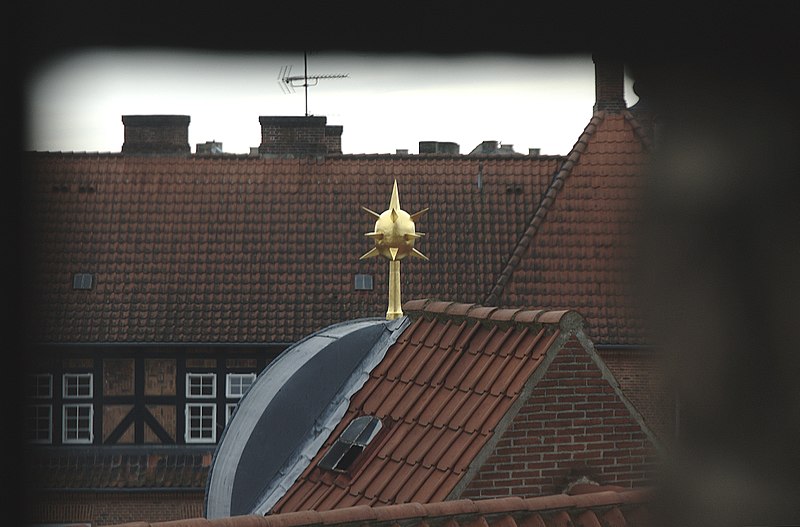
26, 153, 563, 343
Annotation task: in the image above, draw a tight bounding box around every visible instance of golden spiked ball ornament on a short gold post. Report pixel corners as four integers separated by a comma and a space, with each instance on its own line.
360, 180, 428, 320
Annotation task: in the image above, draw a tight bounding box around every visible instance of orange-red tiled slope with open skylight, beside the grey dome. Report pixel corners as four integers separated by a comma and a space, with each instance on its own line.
272, 300, 580, 512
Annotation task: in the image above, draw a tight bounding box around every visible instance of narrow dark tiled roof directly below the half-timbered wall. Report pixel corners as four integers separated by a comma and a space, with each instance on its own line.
25, 445, 213, 490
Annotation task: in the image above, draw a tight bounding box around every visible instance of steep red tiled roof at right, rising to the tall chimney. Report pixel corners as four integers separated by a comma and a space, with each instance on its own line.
485, 111, 649, 344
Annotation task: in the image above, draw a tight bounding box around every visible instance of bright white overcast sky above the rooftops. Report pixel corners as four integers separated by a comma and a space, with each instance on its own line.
25, 50, 637, 154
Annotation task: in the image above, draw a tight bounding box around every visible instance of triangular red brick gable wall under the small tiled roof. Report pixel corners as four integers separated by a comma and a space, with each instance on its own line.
461, 337, 654, 499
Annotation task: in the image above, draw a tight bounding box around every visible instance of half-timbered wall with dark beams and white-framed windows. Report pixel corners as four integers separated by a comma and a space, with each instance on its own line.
26, 346, 280, 445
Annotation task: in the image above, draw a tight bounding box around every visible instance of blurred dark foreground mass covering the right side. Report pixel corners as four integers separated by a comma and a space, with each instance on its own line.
638, 57, 800, 526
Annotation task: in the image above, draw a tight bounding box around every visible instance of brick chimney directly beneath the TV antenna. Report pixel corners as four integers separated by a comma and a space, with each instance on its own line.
258, 116, 343, 157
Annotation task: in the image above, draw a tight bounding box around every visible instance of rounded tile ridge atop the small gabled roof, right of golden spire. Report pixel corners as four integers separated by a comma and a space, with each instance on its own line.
403, 298, 583, 329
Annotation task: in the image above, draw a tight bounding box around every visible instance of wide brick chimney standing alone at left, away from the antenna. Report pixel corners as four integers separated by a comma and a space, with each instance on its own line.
122, 115, 191, 155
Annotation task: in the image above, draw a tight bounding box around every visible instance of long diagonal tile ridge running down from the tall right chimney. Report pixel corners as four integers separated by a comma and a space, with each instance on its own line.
484, 110, 606, 310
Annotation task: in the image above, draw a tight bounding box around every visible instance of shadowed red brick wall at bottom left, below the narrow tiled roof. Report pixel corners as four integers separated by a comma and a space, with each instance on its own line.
28, 491, 203, 526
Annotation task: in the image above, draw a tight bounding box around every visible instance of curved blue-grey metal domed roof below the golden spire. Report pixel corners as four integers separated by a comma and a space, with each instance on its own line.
206, 317, 408, 518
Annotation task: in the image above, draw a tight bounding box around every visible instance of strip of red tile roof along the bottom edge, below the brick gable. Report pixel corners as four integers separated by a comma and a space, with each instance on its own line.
108, 489, 656, 527
